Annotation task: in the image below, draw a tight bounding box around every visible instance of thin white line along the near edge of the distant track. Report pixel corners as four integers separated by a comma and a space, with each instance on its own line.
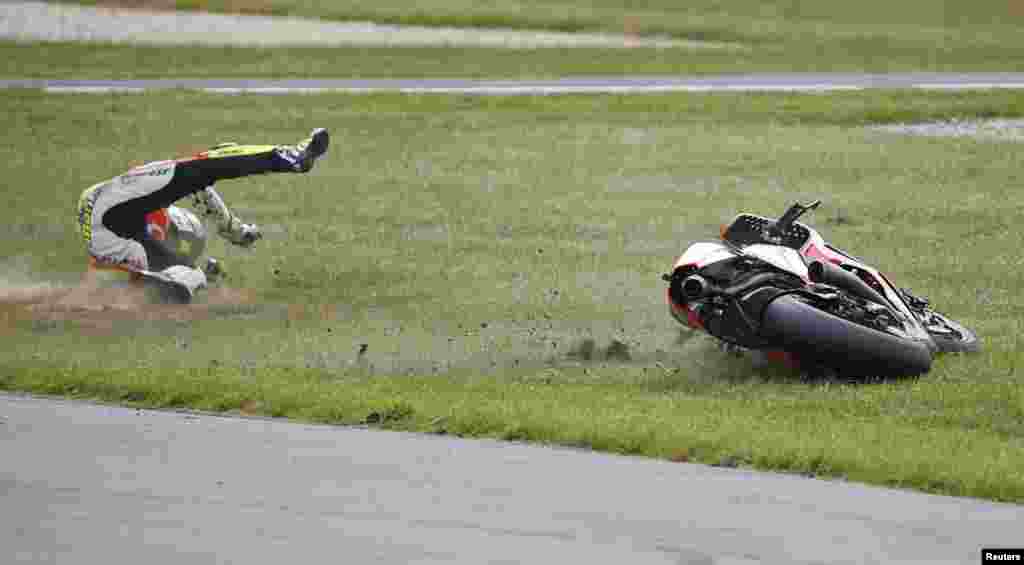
44, 83, 1024, 95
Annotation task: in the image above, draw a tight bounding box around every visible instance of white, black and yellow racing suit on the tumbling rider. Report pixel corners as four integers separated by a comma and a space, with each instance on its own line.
78, 143, 298, 291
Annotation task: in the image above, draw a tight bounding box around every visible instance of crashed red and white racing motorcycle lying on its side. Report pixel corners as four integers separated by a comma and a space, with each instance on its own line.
663, 201, 980, 378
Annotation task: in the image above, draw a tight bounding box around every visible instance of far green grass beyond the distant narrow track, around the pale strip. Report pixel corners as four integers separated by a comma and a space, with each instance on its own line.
39, 0, 1024, 78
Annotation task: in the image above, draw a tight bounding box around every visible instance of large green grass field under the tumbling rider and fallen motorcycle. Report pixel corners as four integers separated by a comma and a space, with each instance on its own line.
0, 90, 1024, 502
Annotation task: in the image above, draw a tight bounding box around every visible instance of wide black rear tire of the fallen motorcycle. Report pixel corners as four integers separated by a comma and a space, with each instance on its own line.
761, 295, 932, 377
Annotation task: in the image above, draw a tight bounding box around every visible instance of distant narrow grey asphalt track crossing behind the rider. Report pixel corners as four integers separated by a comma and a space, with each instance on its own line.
6, 73, 1024, 95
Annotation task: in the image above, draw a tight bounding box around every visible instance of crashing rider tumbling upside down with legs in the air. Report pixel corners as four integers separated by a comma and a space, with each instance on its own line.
78, 129, 330, 295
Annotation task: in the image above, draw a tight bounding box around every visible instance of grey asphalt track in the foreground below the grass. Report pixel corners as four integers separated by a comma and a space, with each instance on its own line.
6, 395, 1024, 565
